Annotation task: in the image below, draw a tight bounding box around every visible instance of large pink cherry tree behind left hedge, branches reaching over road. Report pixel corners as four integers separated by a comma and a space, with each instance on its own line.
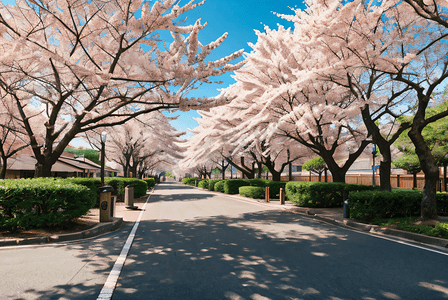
0, 0, 242, 177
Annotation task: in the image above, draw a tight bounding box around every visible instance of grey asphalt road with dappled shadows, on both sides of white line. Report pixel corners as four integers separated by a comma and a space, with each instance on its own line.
0, 183, 448, 300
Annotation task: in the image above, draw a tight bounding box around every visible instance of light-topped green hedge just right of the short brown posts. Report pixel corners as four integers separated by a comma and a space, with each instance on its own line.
286, 181, 379, 207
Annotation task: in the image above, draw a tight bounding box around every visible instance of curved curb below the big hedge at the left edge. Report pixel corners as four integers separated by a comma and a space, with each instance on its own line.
0, 218, 123, 247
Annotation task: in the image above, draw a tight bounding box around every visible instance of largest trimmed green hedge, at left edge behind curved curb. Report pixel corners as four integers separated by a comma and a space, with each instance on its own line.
0, 178, 95, 230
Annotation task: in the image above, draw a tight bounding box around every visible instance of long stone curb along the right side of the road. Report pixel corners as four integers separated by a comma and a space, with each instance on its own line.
194, 187, 448, 249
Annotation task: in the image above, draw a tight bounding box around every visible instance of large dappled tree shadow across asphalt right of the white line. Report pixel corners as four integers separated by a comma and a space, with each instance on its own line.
113, 210, 448, 299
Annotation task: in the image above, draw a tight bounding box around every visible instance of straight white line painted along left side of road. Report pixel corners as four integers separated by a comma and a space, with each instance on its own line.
97, 195, 151, 300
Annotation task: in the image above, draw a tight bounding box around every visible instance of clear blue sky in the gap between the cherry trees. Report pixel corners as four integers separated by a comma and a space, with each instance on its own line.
1, 0, 304, 144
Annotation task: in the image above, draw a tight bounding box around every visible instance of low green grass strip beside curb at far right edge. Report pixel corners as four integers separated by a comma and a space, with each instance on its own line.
370, 217, 448, 239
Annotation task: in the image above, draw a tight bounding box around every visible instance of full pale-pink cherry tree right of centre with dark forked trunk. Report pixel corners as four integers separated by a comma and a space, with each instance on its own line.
215, 26, 368, 182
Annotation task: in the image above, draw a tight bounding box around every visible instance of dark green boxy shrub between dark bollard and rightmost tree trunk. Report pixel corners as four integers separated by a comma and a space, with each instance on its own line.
348, 190, 423, 220
